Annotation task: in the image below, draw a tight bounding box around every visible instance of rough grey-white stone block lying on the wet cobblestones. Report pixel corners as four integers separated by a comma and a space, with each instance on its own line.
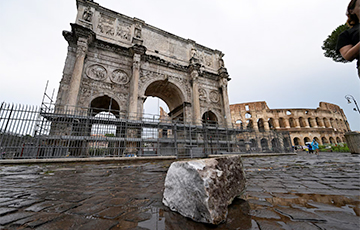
163, 156, 245, 224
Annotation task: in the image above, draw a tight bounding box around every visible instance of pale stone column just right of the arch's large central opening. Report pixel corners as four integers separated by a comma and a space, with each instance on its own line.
189, 63, 201, 125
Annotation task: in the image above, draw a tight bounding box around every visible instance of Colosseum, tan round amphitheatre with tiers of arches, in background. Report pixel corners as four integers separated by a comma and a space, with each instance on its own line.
230, 101, 350, 150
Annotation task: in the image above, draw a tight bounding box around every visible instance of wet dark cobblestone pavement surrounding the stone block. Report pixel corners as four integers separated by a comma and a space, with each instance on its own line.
0, 153, 360, 230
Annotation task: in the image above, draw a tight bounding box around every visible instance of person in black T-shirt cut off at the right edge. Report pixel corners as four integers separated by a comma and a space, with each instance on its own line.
336, 0, 360, 78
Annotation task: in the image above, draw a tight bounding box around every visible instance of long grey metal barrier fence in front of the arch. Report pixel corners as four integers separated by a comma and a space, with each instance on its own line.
0, 103, 292, 159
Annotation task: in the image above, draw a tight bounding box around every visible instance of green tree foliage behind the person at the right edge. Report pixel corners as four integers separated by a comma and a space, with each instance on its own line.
321, 24, 349, 63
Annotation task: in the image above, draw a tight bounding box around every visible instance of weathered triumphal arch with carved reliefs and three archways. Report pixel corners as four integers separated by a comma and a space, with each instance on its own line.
56, 0, 232, 128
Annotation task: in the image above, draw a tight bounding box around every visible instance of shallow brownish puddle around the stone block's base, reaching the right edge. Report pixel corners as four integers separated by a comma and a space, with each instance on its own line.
137, 193, 360, 230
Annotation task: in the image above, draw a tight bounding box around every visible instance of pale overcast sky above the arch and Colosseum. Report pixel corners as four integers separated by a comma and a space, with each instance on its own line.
0, 0, 360, 131
